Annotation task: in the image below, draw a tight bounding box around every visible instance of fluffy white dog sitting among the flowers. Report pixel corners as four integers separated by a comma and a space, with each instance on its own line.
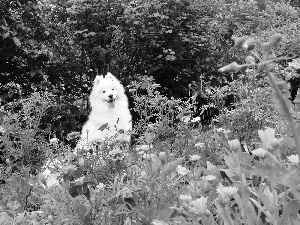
81, 73, 132, 142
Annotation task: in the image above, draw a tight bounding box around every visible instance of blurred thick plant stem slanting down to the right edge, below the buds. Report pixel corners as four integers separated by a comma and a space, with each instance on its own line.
265, 65, 300, 160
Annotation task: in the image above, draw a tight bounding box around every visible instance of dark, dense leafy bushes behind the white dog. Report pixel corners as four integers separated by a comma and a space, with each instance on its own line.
0, 0, 299, 137
